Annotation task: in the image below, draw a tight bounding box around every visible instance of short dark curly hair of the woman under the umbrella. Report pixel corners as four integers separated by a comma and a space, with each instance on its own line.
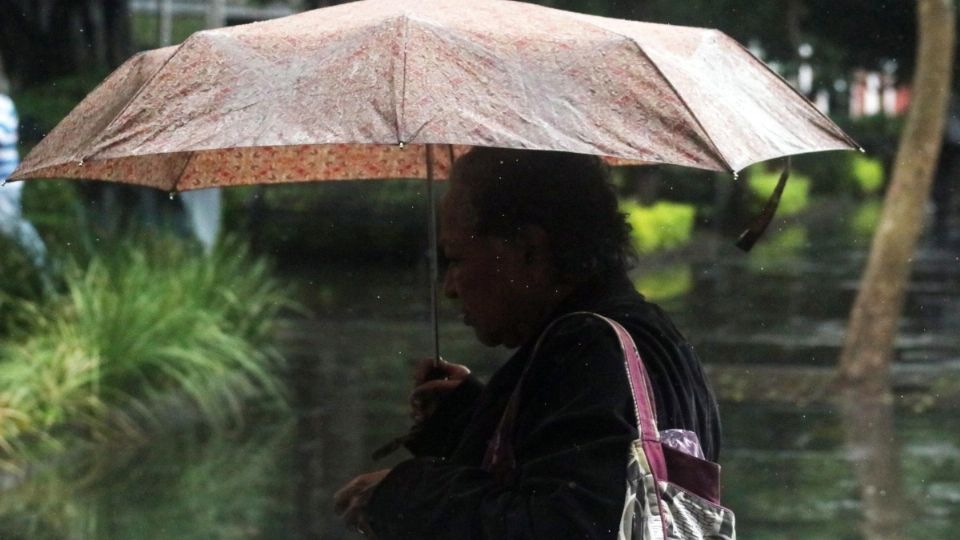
451, 147, 636, 282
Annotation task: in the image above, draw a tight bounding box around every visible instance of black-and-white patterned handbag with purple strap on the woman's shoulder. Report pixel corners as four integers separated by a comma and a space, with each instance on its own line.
484, 312, 736, 540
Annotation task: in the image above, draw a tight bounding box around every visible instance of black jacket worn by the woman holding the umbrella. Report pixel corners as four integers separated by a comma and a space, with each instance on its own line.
367, 277, 720, 540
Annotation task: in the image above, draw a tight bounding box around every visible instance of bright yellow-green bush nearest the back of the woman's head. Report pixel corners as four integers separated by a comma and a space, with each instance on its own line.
620, 201, 696, 253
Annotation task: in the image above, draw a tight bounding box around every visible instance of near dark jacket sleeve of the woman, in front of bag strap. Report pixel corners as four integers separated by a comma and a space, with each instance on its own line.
367, 318, 636, 540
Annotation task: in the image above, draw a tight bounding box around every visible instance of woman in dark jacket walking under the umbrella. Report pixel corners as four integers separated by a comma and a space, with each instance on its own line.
335, 148, 720, 540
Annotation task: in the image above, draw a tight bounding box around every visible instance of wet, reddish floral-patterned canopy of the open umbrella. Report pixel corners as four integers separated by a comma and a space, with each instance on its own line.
11, 0, 856, 190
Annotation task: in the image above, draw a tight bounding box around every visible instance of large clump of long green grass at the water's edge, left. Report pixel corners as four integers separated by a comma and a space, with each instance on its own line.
0, 237, 289, 464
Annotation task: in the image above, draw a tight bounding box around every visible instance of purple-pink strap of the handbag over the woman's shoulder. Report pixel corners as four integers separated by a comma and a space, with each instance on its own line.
483, 311, 667, 480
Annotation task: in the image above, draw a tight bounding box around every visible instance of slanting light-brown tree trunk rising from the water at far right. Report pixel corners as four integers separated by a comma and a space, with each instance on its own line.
839, 0, 956, 393
